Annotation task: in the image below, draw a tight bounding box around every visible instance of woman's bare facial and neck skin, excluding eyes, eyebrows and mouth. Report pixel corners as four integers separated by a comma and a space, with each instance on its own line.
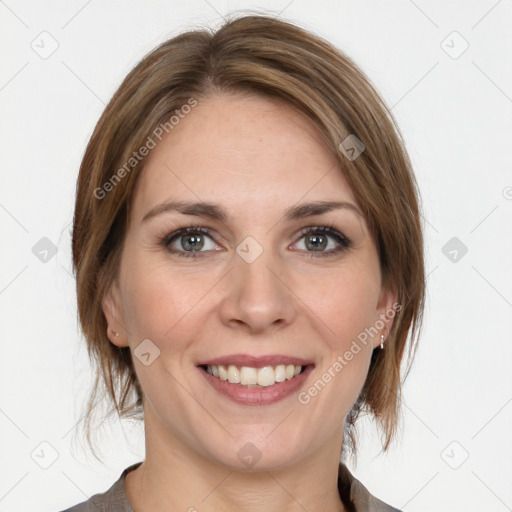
103, 94, 397, 512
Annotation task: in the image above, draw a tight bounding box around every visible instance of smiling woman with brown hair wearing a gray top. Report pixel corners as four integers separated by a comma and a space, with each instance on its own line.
60, 16, 425, 512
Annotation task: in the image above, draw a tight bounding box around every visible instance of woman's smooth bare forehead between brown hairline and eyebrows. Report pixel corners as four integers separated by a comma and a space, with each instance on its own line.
134, 95, 355, 217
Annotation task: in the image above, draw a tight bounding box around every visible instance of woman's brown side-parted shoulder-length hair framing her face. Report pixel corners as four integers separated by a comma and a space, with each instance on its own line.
72, 15, 425, 457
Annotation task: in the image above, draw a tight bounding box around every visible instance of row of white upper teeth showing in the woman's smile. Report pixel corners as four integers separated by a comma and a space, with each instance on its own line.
206, 364, 302, 387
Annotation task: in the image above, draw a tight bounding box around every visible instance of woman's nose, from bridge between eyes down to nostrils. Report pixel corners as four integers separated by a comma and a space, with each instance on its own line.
219, 242, 297, 334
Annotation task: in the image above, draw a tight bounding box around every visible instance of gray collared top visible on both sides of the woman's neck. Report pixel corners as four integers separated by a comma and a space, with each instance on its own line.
62, 462, 401, 512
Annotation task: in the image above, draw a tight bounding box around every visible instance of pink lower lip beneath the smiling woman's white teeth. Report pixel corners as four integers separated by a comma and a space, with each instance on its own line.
198, 364, 313, 405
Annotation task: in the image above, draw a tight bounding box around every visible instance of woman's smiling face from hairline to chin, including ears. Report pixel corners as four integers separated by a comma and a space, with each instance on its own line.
104, 95, 396, 469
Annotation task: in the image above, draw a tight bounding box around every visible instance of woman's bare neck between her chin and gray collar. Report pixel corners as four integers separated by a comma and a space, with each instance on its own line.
126, 411, 347, 512
